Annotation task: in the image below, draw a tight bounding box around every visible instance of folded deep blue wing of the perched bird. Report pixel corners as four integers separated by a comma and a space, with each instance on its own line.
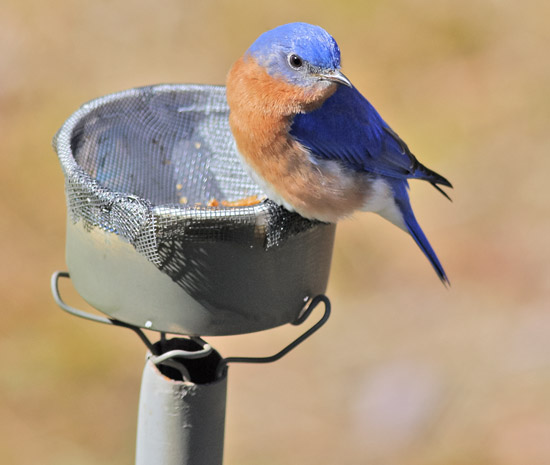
290, 86, 450, 185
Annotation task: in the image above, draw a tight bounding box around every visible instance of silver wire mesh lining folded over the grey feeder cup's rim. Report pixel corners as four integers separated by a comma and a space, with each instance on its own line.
54, 85, 322, 284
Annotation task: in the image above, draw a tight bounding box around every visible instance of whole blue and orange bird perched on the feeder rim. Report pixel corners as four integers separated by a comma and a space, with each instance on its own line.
227, 23, 452, 284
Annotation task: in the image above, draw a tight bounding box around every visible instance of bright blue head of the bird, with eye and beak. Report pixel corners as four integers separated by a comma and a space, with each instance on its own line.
245, 23, 351, 87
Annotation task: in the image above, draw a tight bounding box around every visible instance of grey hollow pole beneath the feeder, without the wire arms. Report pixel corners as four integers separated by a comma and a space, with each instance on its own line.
136, 339, 227, 465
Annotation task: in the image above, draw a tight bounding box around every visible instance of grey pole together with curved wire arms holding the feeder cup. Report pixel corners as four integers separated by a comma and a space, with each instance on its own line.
51, 271, 331, 465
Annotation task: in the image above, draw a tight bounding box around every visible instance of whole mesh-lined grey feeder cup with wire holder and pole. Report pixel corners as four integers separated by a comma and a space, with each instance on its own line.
52, 85, 335, 465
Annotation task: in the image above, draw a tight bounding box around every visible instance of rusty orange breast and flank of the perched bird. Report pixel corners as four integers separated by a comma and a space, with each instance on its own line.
227, 57, 369, 222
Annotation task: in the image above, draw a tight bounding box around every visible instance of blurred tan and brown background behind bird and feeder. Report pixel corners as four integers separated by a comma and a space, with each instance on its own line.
0, 0, 550, 465
